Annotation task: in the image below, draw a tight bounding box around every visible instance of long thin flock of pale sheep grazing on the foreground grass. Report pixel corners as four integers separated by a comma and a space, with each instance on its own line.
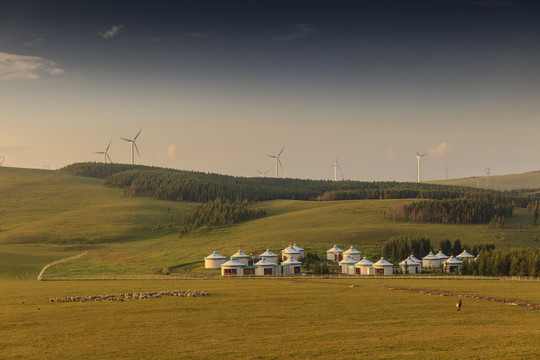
49, 290, 210, 302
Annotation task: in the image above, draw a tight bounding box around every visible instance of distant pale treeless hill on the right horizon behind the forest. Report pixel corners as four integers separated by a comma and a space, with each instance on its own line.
428, 171, 540, 190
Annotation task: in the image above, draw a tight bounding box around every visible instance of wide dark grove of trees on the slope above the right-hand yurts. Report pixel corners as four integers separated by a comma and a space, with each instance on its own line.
386, 199, 513, 224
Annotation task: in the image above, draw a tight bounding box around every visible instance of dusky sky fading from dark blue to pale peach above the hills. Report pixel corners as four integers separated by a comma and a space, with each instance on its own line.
0, 0, 540, 181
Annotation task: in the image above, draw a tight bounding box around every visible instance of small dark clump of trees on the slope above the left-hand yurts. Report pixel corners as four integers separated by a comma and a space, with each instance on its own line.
180, 198, 266, 235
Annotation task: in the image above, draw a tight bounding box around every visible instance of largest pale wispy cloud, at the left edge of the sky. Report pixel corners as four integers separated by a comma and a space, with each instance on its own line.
0, 52, 64, 80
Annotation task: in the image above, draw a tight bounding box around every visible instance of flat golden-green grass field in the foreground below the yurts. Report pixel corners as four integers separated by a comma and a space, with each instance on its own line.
0, 278, 540, 359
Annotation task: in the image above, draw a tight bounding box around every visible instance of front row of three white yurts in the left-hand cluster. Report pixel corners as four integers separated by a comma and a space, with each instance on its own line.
221, 257, 302, 276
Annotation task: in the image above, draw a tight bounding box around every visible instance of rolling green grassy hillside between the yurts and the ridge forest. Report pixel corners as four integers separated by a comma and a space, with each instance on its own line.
0, 168, 540, 278
